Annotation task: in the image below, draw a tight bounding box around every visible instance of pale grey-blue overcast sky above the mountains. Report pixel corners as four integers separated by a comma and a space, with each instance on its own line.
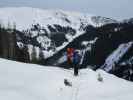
0, 0, 133, 20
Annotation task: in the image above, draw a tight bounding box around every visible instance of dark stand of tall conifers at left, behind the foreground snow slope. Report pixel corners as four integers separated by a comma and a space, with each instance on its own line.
0, 25, 29, 62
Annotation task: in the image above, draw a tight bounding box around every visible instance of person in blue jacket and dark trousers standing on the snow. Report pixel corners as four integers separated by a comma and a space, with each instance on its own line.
73, 50, 81, 76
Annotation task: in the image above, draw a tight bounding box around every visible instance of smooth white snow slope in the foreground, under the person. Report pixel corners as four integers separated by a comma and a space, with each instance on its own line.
0, 59, 133, 100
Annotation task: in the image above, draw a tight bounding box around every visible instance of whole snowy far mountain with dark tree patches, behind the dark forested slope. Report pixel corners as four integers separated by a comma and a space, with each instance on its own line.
0, 7, 117, 58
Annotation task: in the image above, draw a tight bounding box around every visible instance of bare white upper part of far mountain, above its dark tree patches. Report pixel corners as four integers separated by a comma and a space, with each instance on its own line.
0, 7, 117, 32
